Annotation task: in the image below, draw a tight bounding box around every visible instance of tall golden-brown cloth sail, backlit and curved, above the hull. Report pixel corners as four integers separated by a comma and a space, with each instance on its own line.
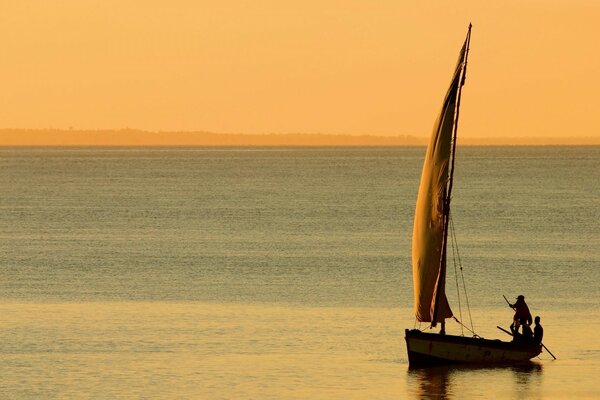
412, 32, 468, 326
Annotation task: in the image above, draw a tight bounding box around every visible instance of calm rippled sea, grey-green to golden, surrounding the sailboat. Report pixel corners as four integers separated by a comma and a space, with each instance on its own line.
0, 147, 600, 399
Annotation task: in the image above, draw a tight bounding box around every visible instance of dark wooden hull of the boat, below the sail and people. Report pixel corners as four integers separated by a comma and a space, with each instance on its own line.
405, 329, 542, 367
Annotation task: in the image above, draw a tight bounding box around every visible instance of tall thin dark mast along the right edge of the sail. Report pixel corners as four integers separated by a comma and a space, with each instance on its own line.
431, 23, 473, 324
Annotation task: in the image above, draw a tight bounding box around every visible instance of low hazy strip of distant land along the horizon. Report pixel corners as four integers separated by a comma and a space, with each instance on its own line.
0, 129, 600, 147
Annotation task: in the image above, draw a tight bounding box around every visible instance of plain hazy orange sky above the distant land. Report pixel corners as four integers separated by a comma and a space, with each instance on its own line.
0, 0, 600, 137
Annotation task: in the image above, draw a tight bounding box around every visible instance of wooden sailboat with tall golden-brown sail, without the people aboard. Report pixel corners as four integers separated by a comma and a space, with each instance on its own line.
405, 24, 541, 367
